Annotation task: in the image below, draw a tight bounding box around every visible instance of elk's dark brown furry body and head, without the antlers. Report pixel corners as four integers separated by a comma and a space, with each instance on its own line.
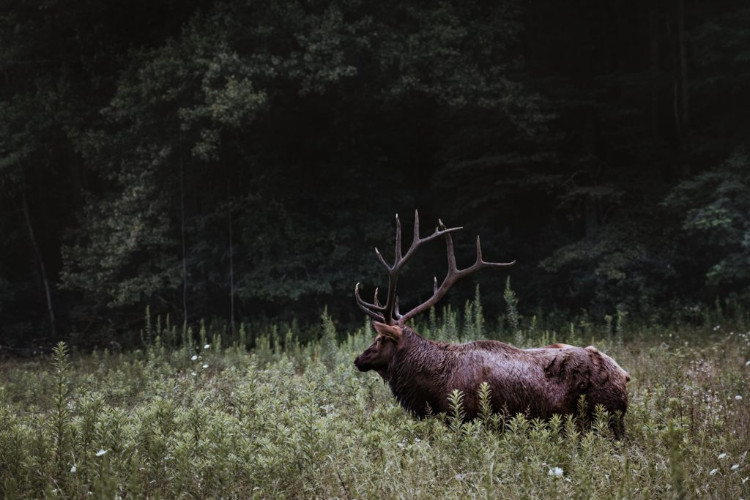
354, 322, 630, 433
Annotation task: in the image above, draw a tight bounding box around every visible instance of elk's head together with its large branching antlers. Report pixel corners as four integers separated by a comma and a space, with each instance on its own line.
354, 210, 515, 380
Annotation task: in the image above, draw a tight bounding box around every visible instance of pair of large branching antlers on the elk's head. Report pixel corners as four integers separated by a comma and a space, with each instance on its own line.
354, 210, 516, 325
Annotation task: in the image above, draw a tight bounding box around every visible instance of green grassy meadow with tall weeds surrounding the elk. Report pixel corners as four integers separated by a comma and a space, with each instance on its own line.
0, 314, 750, 499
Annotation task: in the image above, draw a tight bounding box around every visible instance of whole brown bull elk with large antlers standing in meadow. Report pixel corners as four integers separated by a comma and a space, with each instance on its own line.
354, 211, 630, 435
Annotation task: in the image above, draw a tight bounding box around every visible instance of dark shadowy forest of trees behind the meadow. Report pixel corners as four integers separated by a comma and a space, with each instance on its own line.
0, 0, 750, 345
